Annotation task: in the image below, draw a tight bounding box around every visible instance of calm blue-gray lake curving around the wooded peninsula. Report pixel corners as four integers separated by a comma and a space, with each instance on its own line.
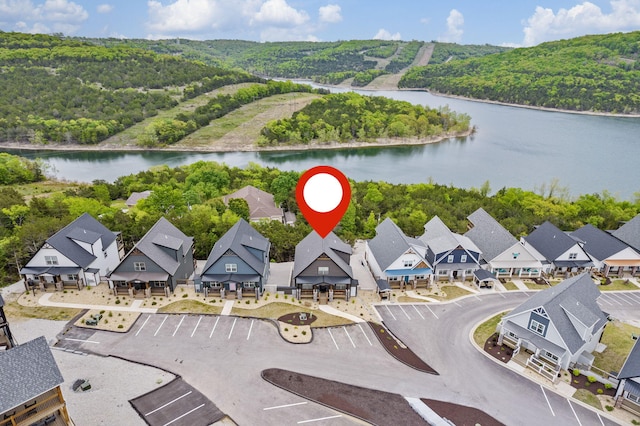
6, 90, 640, 199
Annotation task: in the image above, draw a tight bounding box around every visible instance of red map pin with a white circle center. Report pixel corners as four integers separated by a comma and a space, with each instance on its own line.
296, 166, 351, 238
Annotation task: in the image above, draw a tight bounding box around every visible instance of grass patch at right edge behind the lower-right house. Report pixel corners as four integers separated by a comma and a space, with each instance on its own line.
593, 320, 640, 372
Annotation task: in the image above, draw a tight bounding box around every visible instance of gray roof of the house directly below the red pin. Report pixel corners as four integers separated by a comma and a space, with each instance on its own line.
293, 231, 353, 279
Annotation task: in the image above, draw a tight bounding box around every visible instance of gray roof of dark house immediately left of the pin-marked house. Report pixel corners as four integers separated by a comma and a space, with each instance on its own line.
202, 219, 270, 276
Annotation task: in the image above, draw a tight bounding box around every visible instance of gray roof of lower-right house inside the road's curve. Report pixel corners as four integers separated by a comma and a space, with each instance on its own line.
505, 274, 607, 354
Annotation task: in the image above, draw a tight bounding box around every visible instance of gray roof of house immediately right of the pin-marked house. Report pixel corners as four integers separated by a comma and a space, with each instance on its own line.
368, 218, 426, 271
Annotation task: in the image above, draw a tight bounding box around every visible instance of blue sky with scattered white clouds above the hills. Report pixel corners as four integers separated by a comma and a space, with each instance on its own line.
0, 0, 640, 47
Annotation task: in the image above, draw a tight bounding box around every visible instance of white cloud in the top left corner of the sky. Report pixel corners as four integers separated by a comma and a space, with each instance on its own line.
0, 0, 89, 34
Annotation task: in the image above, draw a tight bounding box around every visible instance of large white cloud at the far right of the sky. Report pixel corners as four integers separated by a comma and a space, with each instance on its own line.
523, 0, 640, 46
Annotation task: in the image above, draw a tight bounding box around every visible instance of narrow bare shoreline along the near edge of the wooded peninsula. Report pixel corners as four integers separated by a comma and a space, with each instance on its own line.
0, 131, 476, 153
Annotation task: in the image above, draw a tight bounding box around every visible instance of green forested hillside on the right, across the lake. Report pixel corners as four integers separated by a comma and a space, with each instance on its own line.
400, 31, 640, 114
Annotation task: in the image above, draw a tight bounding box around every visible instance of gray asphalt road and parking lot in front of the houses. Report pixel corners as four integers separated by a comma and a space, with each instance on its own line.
62, 292, 640, 426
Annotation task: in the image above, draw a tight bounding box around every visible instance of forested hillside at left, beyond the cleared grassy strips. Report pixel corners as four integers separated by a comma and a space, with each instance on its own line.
0, 32, 261, 144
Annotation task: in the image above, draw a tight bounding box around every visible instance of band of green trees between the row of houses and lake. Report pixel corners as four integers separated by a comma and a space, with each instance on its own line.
0, 156, 640, 283
